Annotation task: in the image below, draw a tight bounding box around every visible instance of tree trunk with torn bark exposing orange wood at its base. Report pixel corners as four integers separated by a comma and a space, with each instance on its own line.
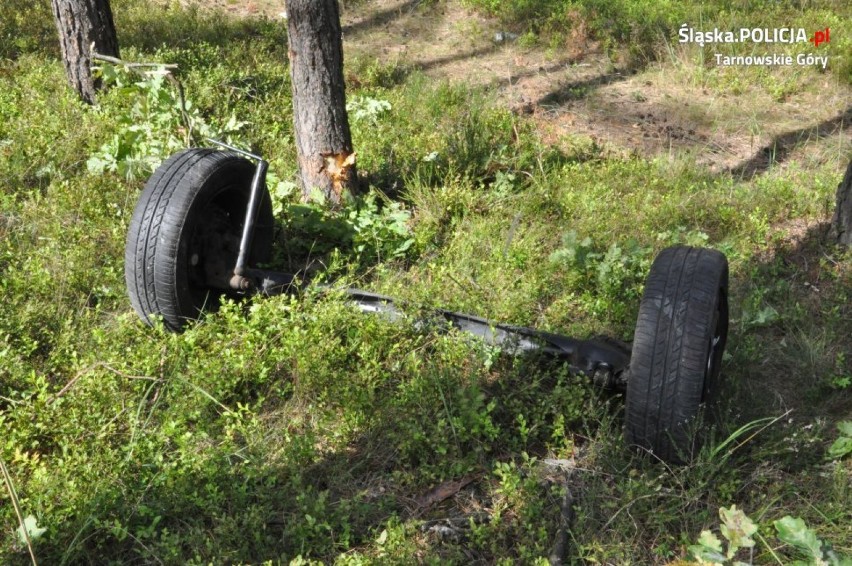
287, 0, 358, 205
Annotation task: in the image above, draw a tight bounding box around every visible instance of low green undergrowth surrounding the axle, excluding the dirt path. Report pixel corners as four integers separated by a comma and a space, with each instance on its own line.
0, 0, 852, 564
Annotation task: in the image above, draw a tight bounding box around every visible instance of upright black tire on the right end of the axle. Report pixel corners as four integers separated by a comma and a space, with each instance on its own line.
625, 246, 728, 463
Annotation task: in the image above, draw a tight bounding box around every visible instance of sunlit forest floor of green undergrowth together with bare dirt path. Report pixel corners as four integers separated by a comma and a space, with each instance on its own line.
0, 0, 852, 566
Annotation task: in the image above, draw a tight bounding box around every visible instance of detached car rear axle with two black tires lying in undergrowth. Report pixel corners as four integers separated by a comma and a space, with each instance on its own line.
125, 145, 728, 463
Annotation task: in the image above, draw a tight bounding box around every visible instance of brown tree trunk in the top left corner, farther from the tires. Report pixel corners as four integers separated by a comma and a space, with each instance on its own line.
51, 0, 119, 104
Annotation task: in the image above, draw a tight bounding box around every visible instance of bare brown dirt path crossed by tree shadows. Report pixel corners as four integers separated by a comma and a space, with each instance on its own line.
168, 0, 852, 178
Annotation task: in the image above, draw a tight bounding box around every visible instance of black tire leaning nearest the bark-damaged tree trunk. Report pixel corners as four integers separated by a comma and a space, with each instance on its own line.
124, 149, 273, 332
